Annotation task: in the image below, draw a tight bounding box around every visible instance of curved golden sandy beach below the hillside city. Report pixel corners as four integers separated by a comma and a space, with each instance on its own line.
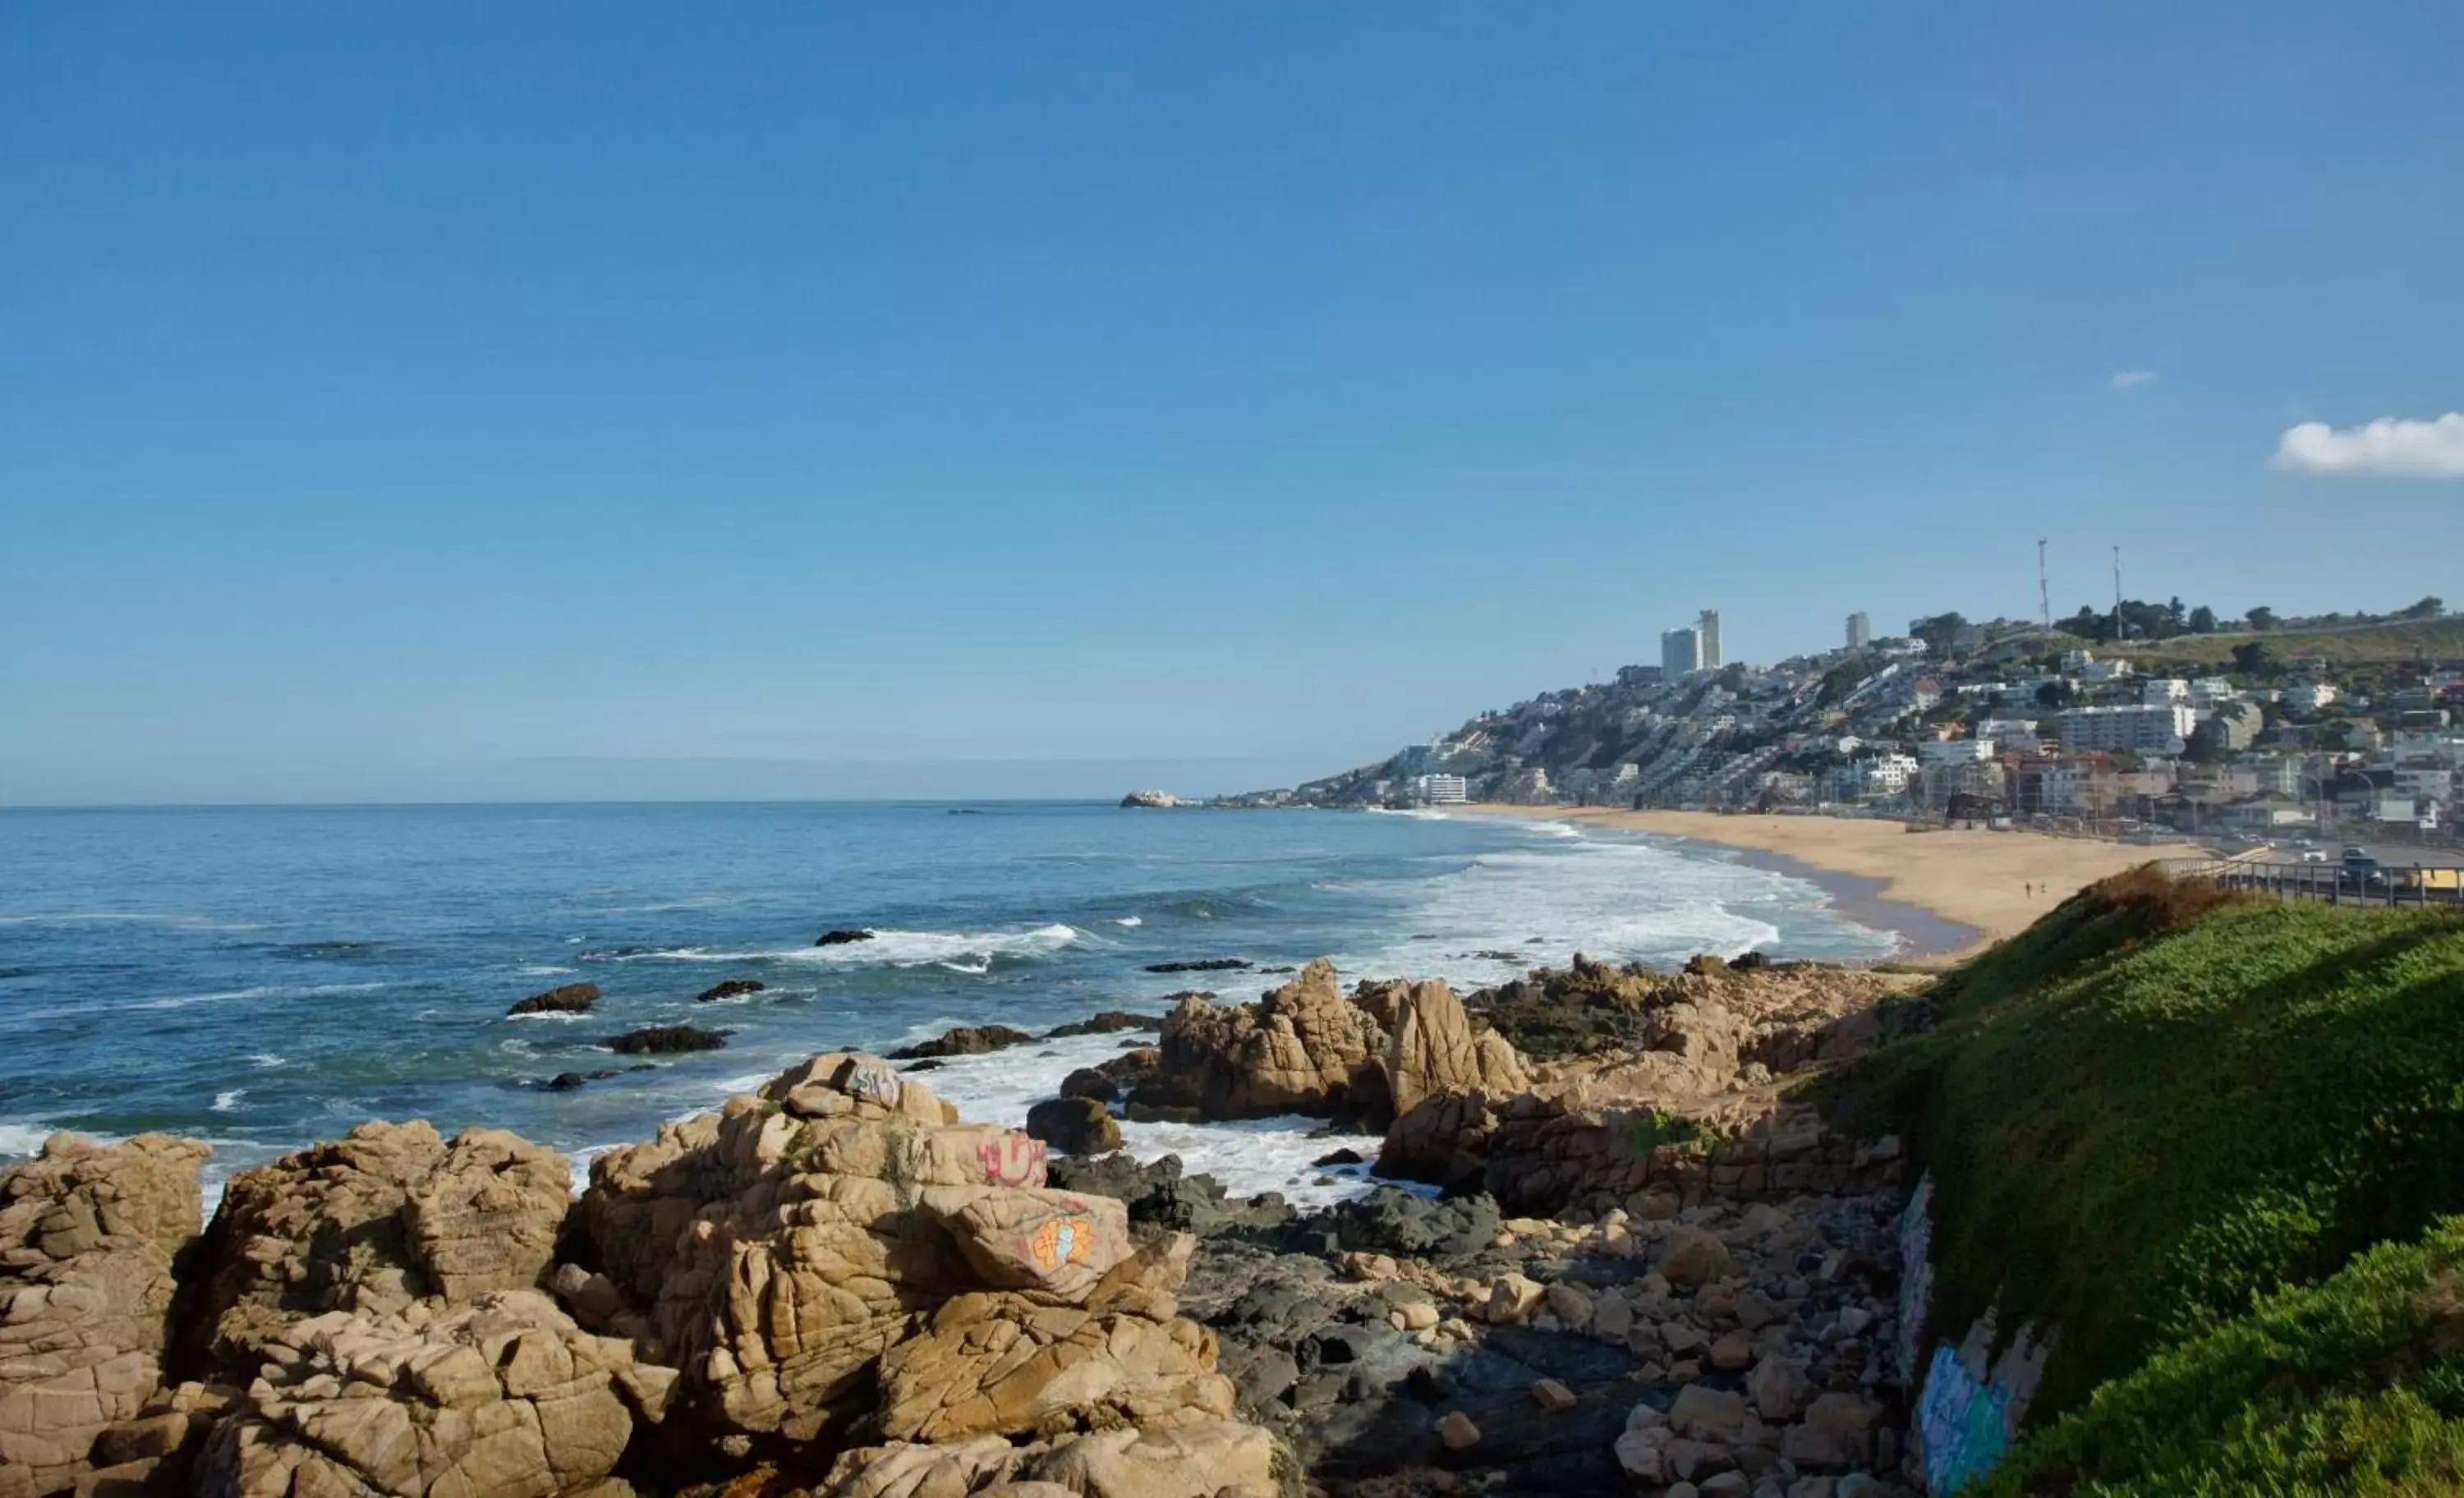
1471, 806, 2161, 961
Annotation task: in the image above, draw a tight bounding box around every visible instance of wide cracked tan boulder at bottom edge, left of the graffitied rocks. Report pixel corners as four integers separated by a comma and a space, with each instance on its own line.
195, 1291, 675, 1498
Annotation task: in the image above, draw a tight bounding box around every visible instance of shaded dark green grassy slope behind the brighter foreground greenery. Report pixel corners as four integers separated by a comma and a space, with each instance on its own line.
1838, 870, 2464, 1491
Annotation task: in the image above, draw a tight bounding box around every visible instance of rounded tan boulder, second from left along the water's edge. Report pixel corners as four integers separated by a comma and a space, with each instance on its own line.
182, 1121, 572, 1382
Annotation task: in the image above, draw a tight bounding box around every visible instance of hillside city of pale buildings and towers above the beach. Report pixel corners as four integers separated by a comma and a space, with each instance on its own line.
1225, 599, 2464, 843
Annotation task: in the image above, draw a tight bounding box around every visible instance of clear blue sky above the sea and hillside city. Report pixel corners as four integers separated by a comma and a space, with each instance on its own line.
0, 0, 2464, 801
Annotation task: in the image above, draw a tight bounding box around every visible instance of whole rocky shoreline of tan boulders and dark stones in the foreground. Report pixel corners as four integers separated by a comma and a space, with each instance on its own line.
0, 958, 1907, 1498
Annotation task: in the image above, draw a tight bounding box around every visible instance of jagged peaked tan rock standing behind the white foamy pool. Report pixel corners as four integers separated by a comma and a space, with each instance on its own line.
1141, 958, 1387, 1119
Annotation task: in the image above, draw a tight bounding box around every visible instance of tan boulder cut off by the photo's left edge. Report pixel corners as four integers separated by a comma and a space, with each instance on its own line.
0, 1133, 207, 1498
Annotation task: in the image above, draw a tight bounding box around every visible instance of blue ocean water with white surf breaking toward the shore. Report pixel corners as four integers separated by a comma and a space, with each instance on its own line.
0, 803, 1895, 1202
